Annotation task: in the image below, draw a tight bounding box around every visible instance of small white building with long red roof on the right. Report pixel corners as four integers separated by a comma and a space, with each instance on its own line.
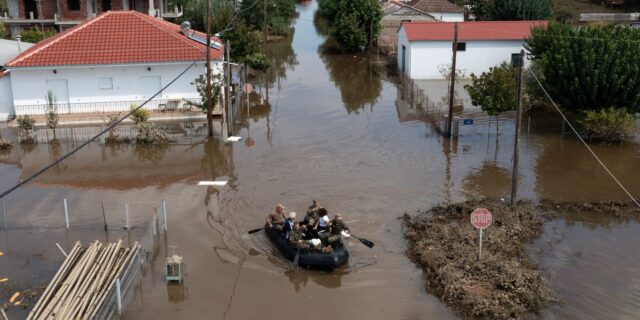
398, 21, 546, 79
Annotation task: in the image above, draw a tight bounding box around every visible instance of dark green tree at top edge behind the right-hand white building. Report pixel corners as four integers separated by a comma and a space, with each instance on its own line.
491, 0, 554, 20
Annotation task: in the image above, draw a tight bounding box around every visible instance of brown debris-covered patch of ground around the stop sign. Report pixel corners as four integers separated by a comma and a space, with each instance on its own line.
404, 200, 640, 319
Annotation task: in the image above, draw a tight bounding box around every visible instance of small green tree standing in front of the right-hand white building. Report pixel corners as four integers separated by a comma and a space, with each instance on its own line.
464, 62, 518, 130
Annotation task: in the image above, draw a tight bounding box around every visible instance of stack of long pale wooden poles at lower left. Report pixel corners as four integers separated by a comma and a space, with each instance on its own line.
27, 240, 140, 320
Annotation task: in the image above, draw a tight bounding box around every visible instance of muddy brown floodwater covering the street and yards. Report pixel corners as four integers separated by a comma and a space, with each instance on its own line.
0, 2, 640, 319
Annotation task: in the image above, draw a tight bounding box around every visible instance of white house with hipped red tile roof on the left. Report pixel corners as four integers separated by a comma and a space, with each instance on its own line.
5, 11, 224, 119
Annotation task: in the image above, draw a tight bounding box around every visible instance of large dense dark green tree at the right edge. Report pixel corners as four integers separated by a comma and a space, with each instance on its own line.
526, 23, 640, 112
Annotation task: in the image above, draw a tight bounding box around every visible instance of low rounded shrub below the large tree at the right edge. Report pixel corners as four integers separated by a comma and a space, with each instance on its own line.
580, 107, 636, 143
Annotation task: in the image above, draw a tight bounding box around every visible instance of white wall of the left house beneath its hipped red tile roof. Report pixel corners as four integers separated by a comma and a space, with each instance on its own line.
6, 62, 222, 115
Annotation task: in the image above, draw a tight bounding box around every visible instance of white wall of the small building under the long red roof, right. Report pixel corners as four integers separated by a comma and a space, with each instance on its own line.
398, 29, 528, 79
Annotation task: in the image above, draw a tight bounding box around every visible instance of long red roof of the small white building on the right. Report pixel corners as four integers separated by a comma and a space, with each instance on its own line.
402, 21, 547, 41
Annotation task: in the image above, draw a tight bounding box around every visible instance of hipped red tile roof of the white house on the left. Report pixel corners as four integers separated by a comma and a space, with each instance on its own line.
7, 11, 223, 67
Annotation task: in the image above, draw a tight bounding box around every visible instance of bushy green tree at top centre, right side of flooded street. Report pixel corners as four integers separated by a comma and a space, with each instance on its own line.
318, 0, 382, 51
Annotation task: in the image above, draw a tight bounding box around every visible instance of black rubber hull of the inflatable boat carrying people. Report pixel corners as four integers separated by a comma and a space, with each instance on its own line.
264, 226, 349, 269
